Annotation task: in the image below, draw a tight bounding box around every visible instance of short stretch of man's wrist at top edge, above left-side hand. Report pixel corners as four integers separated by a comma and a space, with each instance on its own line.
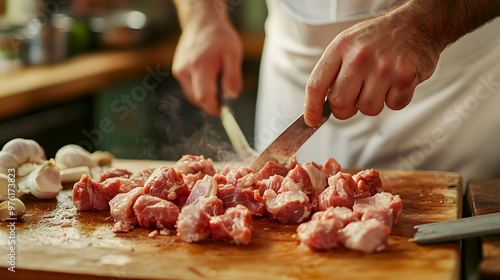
174, 0, 229, 29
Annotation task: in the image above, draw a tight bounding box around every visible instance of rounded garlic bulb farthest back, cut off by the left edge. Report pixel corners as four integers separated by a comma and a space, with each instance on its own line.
0, 138, 46, 174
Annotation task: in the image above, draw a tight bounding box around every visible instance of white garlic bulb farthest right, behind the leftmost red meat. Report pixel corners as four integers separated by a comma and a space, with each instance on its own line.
55, 144, 97, 169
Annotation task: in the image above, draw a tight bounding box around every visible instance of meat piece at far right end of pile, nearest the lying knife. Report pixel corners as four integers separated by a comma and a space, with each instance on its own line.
353, 192, 403, 226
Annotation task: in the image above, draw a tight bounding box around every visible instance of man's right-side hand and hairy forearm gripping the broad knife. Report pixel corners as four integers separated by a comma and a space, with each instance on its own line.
304, 0, 500, 126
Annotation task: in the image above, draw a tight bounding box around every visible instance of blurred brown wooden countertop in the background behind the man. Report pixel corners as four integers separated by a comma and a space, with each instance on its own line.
0, 34, 264, 119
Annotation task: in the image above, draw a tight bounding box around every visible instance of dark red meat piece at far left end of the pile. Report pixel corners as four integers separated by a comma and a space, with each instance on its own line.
72, 174, 123, 211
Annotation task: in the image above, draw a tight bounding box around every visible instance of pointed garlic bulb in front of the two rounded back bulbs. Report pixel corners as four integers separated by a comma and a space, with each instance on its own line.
17, 159, 63, 199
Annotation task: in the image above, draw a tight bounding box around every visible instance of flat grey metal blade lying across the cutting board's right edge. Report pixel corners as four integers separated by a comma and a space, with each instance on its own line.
410, 213, 500, 244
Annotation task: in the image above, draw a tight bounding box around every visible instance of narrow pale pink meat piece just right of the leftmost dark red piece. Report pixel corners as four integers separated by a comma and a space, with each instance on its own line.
109, 188, 144, 232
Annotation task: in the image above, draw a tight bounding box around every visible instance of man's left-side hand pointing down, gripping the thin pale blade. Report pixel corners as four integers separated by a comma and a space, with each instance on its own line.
172, 0, 243, 115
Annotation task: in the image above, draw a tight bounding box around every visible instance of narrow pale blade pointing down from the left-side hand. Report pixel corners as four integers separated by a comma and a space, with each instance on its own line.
219, 95, 257, 164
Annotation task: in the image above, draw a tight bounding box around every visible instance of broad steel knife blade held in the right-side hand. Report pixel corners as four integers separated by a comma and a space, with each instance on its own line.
249, 100, 332, 171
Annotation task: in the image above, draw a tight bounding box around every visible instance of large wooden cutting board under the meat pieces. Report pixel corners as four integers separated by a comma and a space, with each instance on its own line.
0, 160, 462, 280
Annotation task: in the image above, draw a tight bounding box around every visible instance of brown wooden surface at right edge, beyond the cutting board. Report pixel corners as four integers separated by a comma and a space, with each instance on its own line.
467, 179, 500, 279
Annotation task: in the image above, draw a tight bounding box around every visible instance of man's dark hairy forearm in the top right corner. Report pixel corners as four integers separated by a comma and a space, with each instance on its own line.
393, 0, 500, 51
